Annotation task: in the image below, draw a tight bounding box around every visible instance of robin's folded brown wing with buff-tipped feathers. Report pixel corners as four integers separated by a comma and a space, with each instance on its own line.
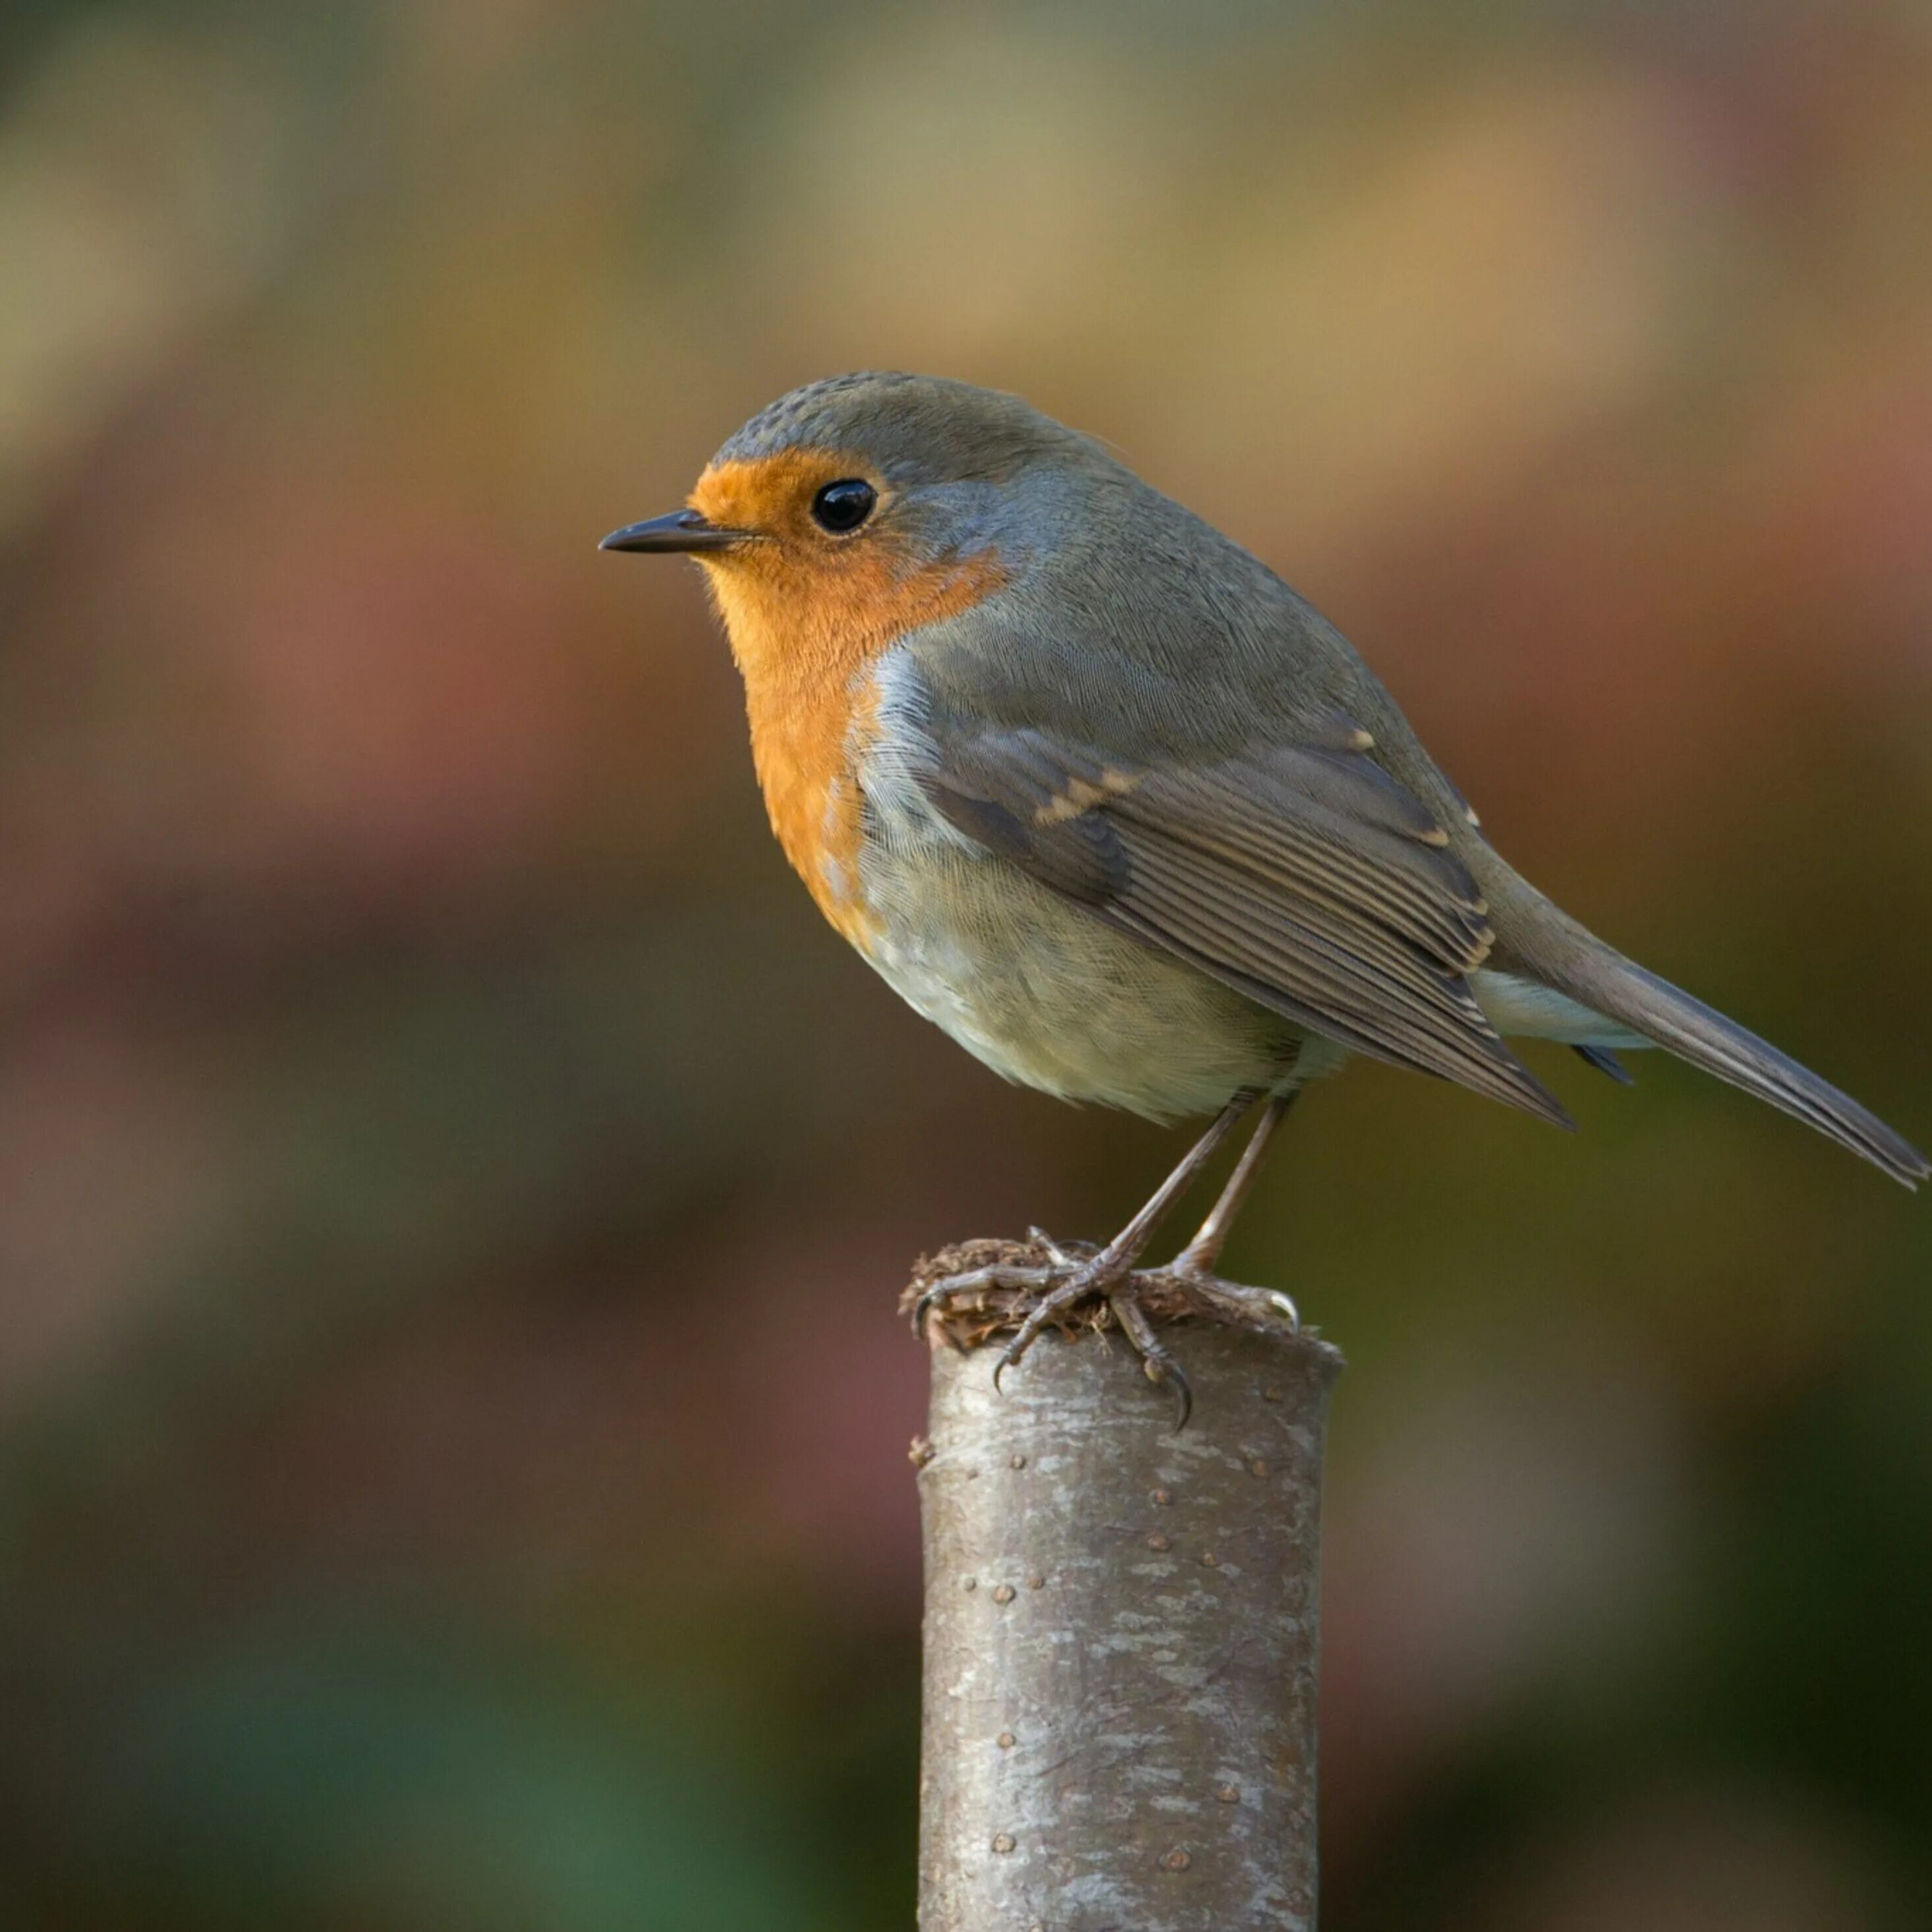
925, 721, 1571, 1126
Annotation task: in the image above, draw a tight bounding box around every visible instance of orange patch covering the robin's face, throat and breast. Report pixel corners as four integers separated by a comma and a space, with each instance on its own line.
690, 450, 1007, 947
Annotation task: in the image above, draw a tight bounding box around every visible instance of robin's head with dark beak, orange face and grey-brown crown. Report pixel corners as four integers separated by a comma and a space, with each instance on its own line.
603, 375, 1111, 661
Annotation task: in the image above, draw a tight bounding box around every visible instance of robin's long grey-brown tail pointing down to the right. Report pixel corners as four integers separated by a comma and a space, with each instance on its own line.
1515, 931, 1932, 1188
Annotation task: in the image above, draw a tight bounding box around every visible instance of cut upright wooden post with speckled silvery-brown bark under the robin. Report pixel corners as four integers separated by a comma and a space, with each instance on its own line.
918, 1251, 1341, 1932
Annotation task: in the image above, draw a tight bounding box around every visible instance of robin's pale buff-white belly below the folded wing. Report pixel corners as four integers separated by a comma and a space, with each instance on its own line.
860, 838, 1341, 1121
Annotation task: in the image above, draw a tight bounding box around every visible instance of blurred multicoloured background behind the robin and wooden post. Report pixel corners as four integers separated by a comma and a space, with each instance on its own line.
0, 0, 1932, 1932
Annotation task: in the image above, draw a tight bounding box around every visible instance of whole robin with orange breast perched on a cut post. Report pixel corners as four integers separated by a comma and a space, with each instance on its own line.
599, 371, 1932, 1422
